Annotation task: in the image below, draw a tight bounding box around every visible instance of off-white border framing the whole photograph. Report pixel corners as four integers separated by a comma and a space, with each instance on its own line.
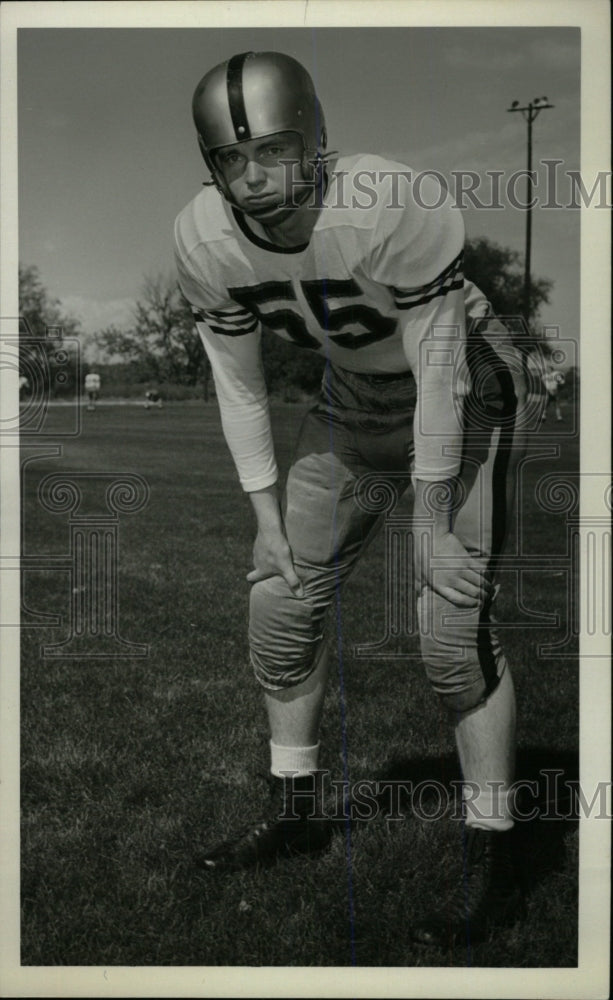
0, 0, 611, 1000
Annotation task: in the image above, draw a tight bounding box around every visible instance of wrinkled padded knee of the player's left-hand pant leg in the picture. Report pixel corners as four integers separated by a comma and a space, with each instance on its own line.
249, 577, 323, 690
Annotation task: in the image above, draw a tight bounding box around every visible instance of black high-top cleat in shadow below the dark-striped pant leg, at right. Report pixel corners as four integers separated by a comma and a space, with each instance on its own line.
412, 827, 523, 947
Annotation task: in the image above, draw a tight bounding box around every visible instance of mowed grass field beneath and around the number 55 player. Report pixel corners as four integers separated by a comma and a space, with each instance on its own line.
21, 402, 578, 967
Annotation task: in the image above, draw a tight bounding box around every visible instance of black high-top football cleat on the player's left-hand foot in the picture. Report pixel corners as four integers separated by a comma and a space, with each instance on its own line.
196, 776, 332, 872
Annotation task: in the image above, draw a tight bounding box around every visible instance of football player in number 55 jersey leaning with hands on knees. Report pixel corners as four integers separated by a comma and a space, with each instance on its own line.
175, 52, 523, 943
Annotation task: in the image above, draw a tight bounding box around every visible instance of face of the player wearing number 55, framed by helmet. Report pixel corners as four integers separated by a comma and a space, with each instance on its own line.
215, 132, 303, 223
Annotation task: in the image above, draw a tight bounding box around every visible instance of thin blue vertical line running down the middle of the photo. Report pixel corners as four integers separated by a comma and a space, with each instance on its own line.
311, 29, 357, 966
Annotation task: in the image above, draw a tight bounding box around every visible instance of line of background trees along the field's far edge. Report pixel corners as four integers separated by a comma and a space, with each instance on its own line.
19, 237, 553, 399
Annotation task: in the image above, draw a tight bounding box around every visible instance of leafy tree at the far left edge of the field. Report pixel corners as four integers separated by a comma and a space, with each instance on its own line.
19, 265, 80, 396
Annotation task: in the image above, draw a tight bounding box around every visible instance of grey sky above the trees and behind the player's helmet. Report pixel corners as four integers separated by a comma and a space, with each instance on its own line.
18, 27, 580, 358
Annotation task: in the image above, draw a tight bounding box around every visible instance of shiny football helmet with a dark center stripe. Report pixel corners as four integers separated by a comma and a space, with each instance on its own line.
192, 52, 326, 200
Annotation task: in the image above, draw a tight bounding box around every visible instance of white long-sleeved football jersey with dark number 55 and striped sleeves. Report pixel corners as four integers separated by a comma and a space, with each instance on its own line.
175, 155, 480, 490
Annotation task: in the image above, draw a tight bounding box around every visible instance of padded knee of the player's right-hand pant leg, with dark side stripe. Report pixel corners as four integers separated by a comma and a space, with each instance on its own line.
418, 588, 506, 713
